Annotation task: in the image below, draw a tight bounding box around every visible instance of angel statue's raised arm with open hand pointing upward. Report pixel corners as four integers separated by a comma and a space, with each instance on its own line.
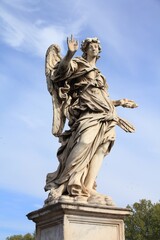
58, 35, 78, 72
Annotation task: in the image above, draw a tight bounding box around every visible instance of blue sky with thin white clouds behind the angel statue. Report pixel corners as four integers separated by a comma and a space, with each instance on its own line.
0, 0, 160, 240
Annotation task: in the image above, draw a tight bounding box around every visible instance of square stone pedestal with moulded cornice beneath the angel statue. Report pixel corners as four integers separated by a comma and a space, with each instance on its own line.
27, 202, 130, 240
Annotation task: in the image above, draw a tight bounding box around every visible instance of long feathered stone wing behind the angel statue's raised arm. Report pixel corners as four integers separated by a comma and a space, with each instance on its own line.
45, 44, 65, 136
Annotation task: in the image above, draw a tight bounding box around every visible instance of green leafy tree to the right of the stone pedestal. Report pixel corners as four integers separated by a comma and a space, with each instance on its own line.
125, 199, 160, 240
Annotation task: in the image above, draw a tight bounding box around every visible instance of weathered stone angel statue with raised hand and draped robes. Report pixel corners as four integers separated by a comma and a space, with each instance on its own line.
45, 35, 137, 205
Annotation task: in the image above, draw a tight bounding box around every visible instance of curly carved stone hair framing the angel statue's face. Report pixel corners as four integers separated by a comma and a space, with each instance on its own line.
81, 37, 102, 59
